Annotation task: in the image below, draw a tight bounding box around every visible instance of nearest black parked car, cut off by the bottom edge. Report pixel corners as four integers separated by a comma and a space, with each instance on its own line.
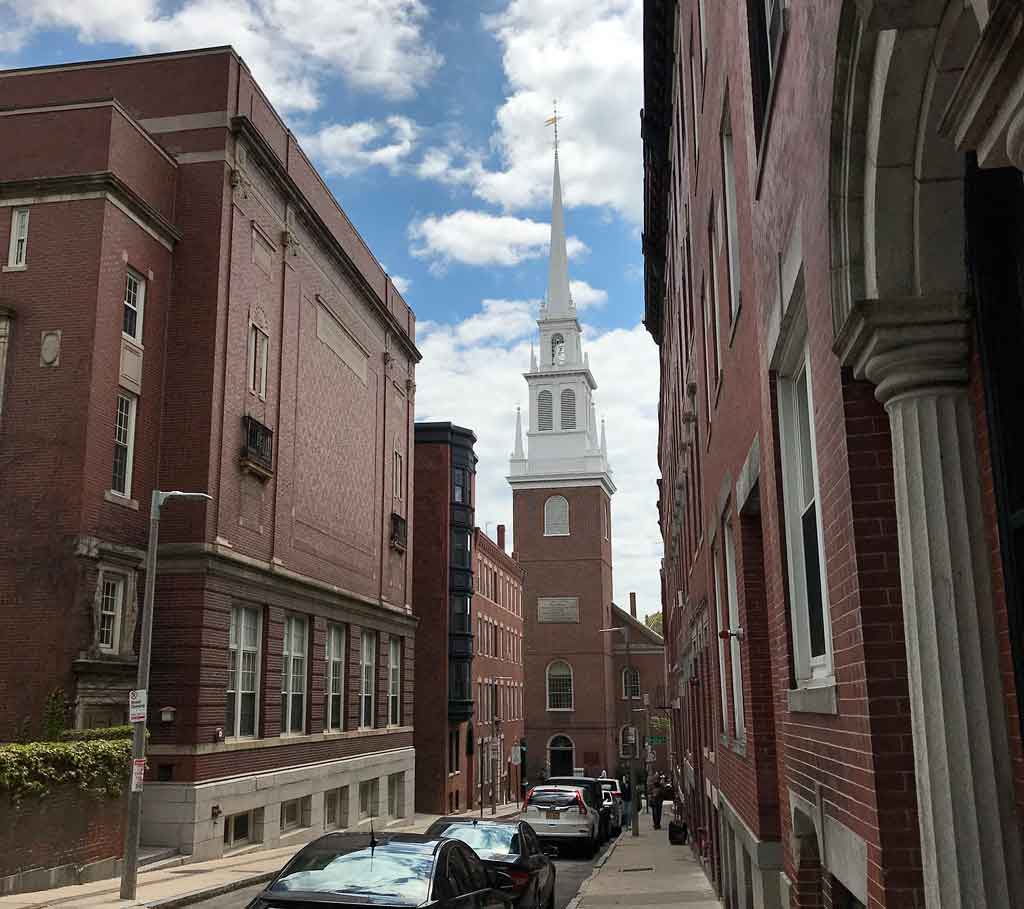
247, 833, 513, 909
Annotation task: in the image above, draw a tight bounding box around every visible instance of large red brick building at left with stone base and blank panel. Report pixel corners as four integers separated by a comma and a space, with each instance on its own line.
0, 47, 419, 857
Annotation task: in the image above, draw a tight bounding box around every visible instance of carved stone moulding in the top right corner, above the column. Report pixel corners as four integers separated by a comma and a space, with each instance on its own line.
939, 0, 1024, 170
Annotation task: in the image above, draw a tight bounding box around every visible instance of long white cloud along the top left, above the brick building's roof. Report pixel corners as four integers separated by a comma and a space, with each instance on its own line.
0, 0, 442, 111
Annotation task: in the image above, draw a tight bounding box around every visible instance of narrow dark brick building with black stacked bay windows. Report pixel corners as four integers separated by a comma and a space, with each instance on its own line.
413, 423, 476, 814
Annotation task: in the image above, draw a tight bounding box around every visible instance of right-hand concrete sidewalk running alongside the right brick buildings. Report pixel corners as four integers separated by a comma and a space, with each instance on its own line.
567, 815, 721, 909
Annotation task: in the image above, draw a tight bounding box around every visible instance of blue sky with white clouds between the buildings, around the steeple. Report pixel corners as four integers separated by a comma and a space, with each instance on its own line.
0, 0, 662, 614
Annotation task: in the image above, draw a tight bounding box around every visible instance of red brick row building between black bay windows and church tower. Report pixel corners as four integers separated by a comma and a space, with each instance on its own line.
470, 524, 525, 805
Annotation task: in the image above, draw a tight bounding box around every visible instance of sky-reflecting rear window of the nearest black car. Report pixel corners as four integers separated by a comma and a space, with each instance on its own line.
270, 848, 433, 906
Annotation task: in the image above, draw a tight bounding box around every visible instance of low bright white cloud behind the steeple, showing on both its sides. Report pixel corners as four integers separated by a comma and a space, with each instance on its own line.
416, 300, 662, 626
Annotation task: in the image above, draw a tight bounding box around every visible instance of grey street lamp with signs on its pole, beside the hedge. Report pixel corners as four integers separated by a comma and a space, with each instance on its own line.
121, 489, 213, 900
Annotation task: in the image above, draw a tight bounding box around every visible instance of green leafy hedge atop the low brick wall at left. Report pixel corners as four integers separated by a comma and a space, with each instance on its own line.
0, 738, 131, 802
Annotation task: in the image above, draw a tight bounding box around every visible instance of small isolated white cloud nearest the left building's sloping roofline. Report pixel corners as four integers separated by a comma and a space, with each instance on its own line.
302, 116, 419, 177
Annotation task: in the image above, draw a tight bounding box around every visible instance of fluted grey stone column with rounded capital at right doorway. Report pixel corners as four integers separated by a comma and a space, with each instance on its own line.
837, 297, 1024, 909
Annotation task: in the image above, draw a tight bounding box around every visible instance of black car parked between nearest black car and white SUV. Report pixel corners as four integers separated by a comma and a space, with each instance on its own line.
426, 816, 558, 909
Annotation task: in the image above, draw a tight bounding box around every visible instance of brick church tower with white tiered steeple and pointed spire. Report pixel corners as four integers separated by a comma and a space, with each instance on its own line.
508, 148, 616, 782
